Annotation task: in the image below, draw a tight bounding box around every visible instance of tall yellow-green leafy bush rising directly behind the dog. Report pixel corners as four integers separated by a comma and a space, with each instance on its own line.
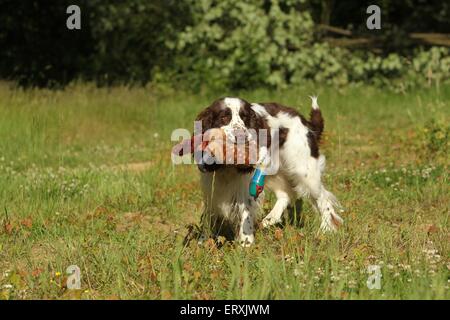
167, 0, 313, 88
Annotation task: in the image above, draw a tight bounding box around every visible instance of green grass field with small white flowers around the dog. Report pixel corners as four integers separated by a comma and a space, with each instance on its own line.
0, 83, 450, 299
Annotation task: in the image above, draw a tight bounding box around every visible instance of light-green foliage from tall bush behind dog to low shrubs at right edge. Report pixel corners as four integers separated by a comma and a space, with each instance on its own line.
160, 0, 450, 91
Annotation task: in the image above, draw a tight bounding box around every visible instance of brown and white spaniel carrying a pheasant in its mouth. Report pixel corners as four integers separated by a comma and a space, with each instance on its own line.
179, 97, 343, 246
